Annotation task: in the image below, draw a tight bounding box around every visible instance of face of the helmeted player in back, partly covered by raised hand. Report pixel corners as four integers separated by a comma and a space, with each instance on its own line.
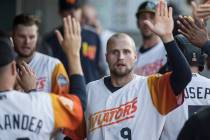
138, 12, 155, 38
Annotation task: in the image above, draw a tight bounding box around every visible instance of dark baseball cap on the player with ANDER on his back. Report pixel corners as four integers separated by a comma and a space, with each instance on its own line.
0, 31, 15, 67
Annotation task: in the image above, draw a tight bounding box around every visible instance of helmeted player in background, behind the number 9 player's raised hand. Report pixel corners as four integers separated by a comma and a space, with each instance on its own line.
134, 1, 167, 76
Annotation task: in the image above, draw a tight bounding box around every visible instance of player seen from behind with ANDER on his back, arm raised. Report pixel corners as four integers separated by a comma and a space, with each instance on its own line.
0, 17, 86, 140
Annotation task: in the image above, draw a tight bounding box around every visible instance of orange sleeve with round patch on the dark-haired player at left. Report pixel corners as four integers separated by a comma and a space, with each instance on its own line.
51, 63, 69, 95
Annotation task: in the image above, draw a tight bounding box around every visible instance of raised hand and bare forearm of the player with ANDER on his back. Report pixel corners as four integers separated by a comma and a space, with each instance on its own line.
55, 16, 83, 75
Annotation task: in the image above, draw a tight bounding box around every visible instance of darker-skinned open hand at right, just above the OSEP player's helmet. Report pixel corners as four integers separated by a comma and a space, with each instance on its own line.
177, 16, 208, 48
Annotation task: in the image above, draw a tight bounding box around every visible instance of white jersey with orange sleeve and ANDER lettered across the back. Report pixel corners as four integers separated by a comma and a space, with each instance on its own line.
0, 91, 83, 140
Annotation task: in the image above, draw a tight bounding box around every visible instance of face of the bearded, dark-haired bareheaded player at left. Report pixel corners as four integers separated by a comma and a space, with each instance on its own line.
13, 25, 38, 57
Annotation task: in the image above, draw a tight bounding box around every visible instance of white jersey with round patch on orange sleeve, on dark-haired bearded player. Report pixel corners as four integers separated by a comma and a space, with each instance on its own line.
29, 52, 69, 94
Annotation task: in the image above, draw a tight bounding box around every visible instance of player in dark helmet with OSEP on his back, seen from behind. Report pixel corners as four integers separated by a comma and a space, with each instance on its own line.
160, 35, 210, 140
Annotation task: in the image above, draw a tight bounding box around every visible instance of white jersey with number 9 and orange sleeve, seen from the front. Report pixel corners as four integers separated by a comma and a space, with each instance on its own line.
86, 73, 183, 140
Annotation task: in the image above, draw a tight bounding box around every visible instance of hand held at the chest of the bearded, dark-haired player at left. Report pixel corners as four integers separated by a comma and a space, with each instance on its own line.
17, 61, 36, 92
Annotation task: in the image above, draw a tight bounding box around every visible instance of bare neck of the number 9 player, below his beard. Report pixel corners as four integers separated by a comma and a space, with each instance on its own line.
111, 72, 134, 87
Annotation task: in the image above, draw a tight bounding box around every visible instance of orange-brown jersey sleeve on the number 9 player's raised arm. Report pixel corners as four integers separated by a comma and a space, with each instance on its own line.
147, 72, 184, 115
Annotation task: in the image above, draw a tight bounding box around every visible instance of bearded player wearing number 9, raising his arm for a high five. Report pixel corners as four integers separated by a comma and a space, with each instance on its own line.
85, 1, 191, 140
